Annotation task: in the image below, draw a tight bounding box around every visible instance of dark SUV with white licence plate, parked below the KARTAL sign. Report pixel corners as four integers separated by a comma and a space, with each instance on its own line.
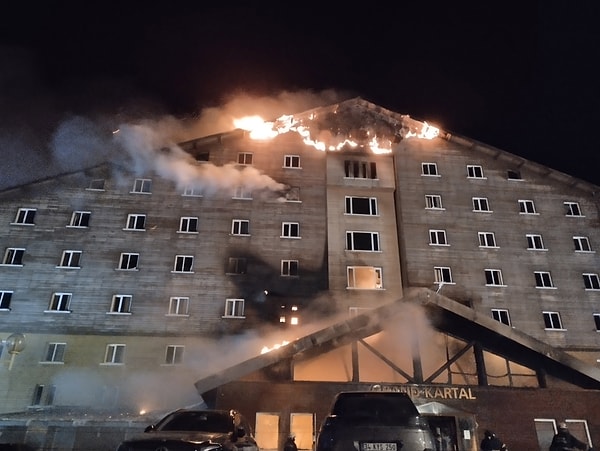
316, 391, 435, 451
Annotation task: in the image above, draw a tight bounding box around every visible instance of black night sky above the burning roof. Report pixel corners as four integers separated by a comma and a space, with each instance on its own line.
0, 0, 600, 184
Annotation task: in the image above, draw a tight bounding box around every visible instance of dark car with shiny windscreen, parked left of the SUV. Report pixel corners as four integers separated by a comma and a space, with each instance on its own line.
117, 409, 259, 451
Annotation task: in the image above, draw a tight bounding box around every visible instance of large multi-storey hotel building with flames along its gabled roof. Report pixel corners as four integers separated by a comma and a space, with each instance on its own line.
0, 98, 600, 451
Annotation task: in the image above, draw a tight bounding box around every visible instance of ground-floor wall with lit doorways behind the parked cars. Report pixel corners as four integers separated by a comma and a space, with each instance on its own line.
0, 381, 600, 451
